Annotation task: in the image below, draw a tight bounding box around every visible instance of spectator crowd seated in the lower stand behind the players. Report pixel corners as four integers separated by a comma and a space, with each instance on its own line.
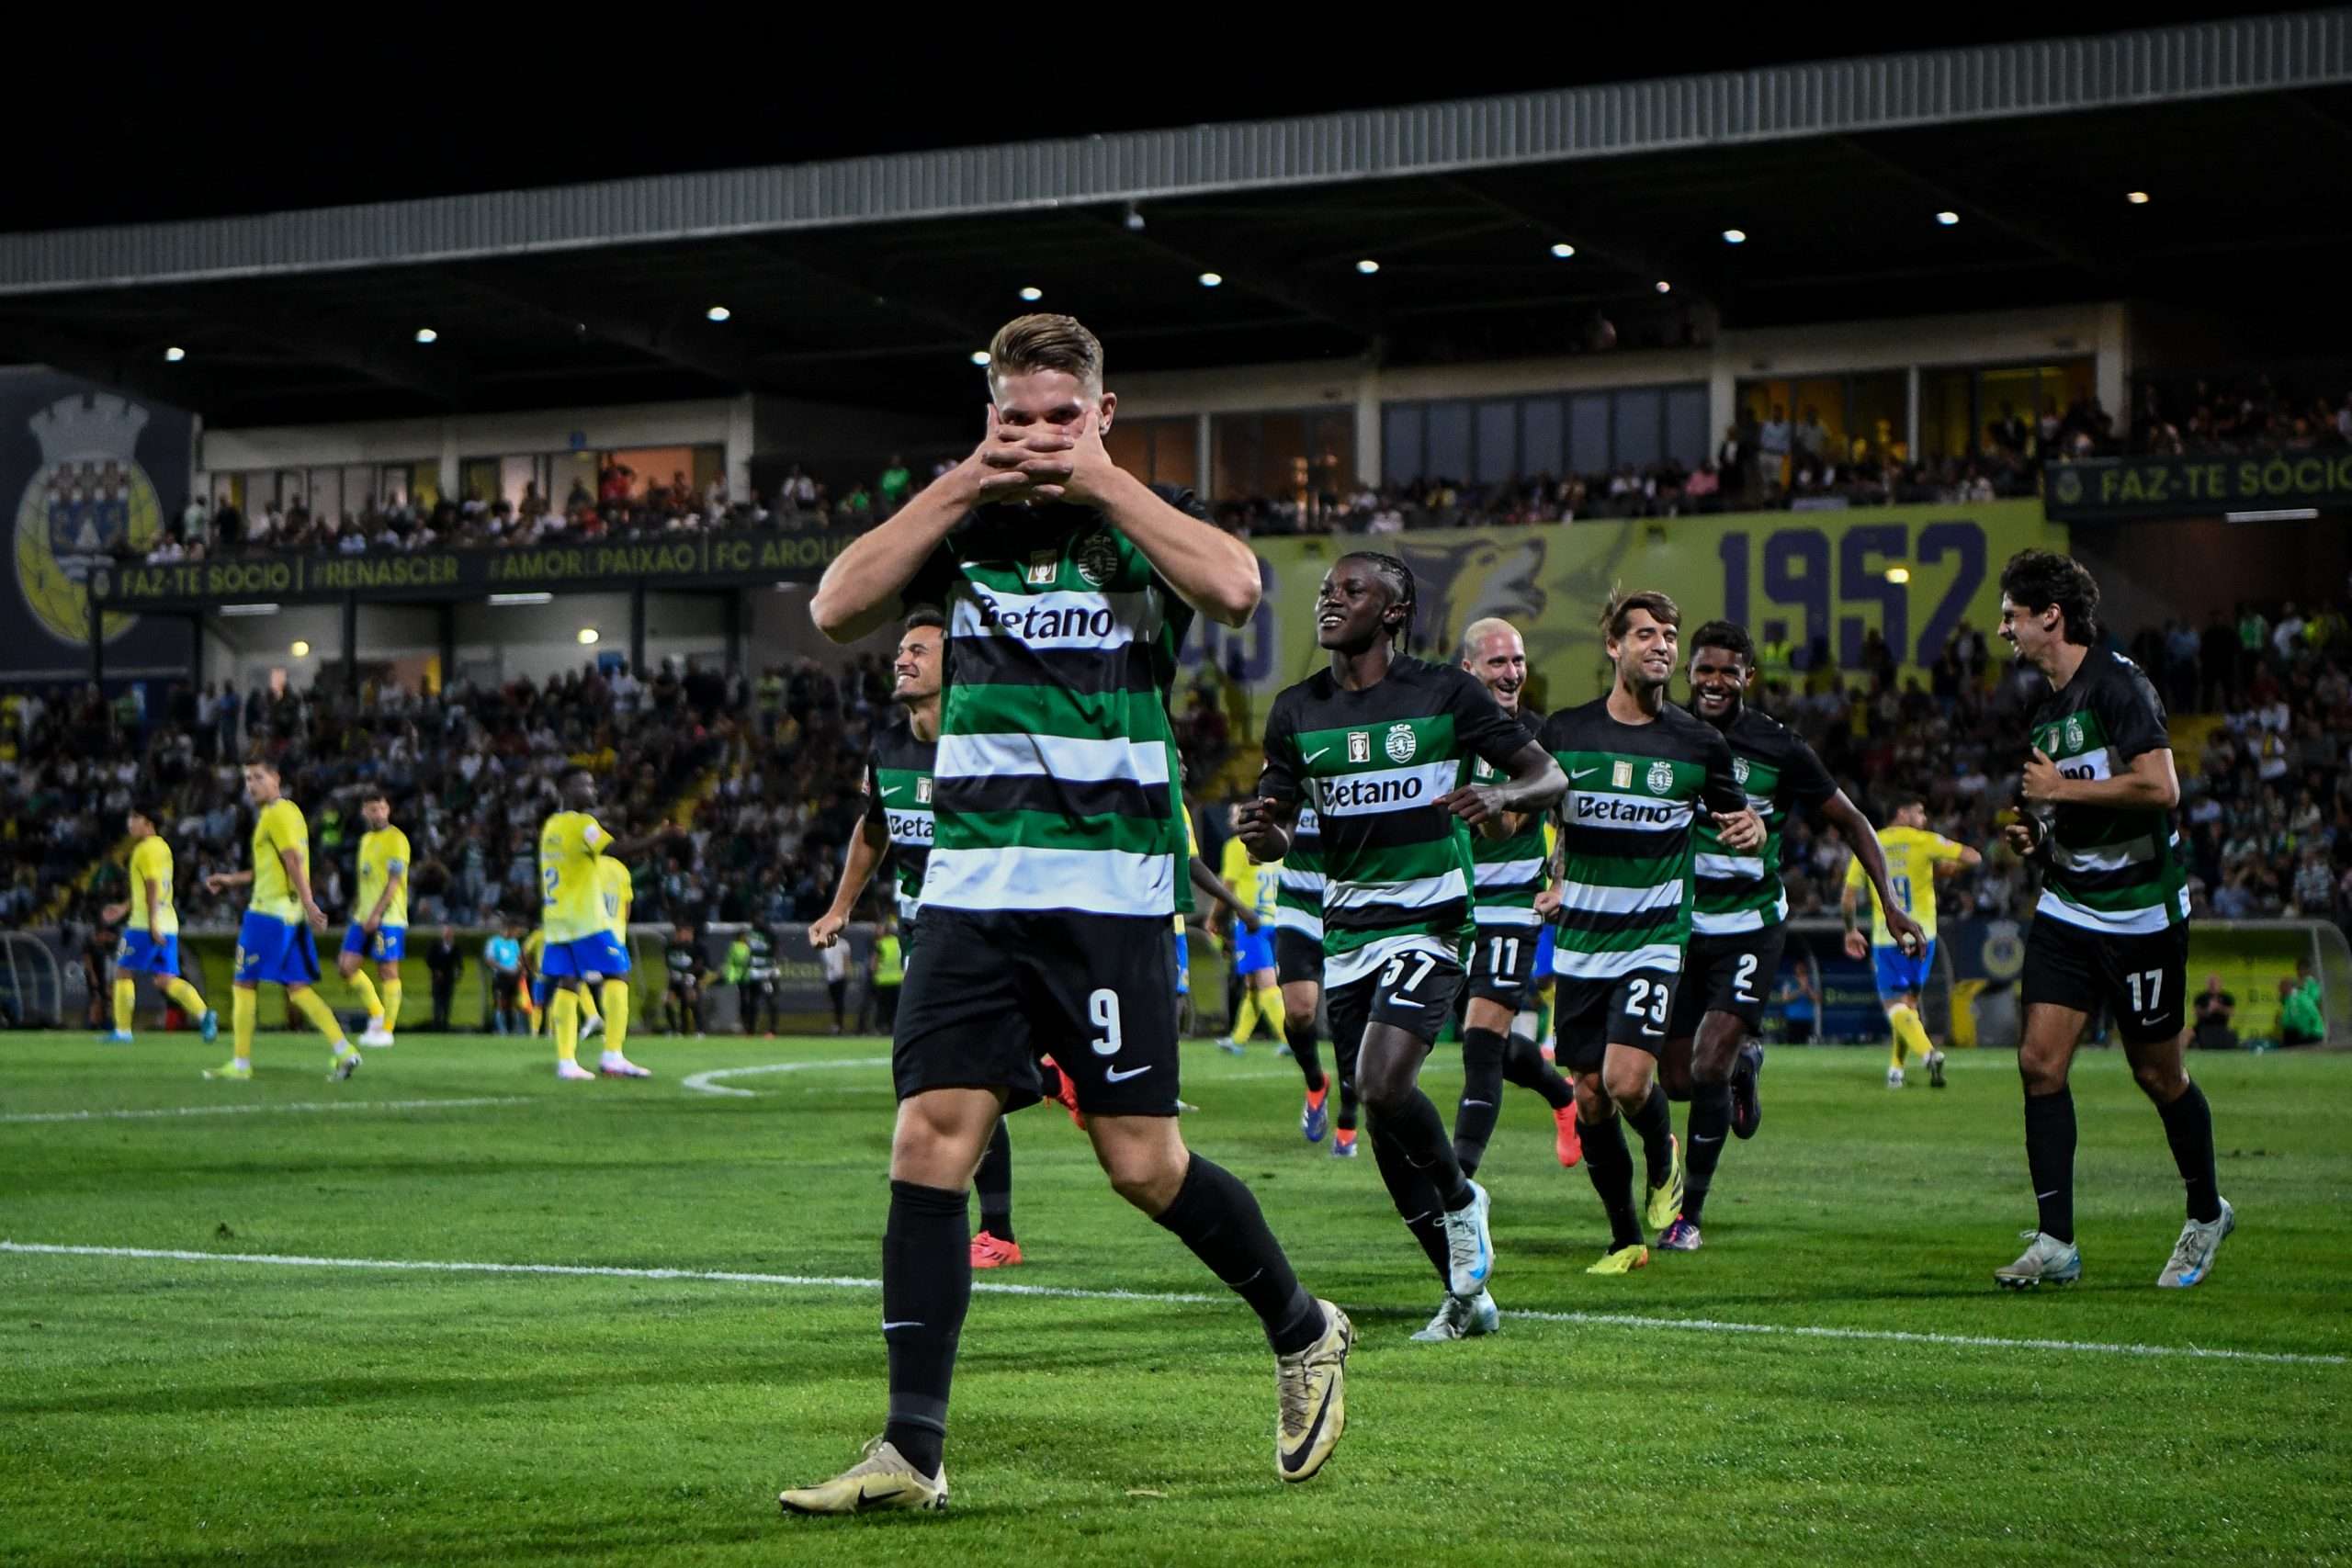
14, 604, 2352, 964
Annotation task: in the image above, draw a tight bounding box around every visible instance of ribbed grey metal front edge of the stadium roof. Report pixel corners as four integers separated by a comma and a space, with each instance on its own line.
0, 9, 2352, 294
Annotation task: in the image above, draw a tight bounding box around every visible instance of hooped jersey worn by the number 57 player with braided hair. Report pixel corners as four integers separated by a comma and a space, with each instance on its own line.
1259, 656, 1529, 985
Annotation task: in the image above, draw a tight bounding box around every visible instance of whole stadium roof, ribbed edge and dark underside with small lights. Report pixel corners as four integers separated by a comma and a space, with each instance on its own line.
0, 12, 2352, 425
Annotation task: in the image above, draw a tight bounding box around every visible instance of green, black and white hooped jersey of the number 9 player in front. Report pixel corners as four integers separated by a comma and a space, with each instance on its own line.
903, 487, 1202, 917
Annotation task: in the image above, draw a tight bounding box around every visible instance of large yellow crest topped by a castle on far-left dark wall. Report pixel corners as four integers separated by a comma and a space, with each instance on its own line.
17, 392, 163, 642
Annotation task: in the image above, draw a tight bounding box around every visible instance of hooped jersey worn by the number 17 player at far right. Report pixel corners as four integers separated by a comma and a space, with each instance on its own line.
2032, 649, 2189, 936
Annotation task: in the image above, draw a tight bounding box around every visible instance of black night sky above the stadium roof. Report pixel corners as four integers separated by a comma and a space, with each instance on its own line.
0, 5, 2267, 231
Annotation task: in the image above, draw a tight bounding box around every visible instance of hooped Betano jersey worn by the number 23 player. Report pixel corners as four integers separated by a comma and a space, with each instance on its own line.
1543, 698, 1746, 980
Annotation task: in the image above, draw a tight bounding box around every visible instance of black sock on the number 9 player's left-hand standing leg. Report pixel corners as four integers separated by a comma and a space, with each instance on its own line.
882, 1180, 971, 1476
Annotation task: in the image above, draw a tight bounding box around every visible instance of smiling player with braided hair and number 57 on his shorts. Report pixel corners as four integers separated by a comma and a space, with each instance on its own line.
1235, 552, 1566, 1340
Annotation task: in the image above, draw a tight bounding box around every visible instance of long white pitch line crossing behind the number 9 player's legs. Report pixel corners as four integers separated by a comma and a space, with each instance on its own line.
0, 1241, 2352, 1366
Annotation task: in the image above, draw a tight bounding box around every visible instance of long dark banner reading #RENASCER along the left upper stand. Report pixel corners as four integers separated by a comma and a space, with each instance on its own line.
92, 529, 852, 609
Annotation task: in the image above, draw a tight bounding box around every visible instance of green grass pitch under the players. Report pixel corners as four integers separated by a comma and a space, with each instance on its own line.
0, 1034, 2352, 1568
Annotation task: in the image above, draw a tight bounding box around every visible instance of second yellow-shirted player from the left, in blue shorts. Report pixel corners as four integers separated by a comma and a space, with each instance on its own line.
205, 761, 360, 1079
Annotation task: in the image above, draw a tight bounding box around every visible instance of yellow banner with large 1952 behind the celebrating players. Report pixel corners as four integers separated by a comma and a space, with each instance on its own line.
1183, 501, 2067, 712
